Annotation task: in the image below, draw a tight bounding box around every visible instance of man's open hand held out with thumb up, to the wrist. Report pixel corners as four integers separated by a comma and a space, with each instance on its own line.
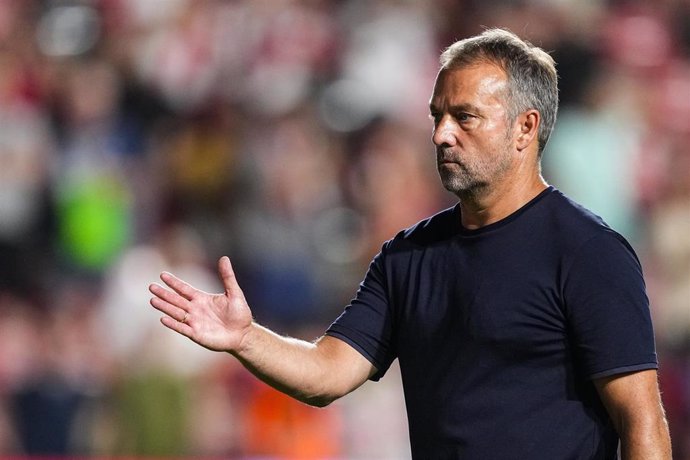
149, 256, 252, 352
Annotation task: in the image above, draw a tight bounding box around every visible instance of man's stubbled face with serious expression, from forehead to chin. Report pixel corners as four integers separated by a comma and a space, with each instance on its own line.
429, 63, 514, 196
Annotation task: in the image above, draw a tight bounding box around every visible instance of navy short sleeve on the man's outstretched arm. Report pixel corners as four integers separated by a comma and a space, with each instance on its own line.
326, 245, 395, 380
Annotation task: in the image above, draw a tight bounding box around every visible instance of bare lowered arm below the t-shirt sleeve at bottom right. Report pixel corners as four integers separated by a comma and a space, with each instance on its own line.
594, 369, 671, 460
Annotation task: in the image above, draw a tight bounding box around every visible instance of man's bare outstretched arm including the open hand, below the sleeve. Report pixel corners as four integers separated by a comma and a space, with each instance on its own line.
149, 257, 376, 406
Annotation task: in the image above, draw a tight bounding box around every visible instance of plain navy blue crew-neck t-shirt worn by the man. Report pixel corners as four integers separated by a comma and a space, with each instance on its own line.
327, 187, 657, 460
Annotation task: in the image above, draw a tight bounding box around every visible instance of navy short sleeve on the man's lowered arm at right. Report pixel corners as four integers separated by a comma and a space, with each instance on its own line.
563, 231, 657, 379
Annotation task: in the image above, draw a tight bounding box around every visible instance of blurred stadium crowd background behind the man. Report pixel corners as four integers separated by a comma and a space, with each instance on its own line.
0, 0, 690, 460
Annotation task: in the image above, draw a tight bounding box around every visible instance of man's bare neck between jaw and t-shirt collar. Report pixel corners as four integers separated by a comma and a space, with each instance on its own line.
458, 173, 548, 230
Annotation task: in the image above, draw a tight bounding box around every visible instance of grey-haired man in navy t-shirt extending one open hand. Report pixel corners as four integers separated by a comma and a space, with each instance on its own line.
150, 30, 670, 460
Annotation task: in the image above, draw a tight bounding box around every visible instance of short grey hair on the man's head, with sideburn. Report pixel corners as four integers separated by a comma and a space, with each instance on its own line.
440, 29, 558, 157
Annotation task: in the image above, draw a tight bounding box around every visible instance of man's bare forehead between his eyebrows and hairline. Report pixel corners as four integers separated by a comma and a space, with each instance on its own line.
431, 63, 508, 107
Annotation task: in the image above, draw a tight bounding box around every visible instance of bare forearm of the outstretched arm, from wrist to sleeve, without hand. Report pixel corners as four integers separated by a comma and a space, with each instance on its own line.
231, 323, 368, 407
